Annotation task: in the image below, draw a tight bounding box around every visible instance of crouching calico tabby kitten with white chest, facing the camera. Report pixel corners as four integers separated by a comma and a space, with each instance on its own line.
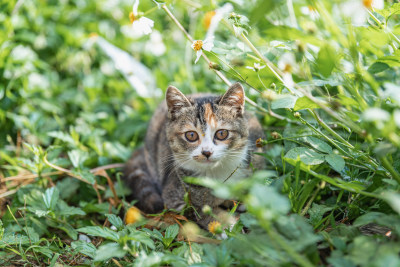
124, 83, 265, 228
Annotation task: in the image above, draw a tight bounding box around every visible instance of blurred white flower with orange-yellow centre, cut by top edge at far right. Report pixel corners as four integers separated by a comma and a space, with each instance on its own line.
340, 0, 385, 26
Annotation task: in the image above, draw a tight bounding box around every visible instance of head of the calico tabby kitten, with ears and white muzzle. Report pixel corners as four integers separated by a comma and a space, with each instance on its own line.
166, 83, 249, 173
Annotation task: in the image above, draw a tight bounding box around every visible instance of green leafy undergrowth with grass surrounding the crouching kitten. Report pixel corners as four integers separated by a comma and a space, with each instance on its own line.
0, 0, 400, 266
